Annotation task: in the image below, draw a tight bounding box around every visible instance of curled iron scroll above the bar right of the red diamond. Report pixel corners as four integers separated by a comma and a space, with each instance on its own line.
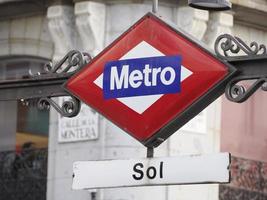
214, 34, 267, 60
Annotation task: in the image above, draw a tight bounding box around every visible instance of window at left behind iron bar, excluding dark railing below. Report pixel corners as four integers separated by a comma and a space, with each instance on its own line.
0, 56, 49, 151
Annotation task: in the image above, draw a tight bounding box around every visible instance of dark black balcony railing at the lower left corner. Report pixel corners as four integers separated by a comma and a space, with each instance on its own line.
0, 149, 47, 200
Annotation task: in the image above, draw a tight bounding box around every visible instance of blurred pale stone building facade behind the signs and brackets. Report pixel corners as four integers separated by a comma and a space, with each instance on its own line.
0, 0, 267, 200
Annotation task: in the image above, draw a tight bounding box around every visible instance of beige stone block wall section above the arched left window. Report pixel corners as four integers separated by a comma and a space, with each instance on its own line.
0, 15, 54, 59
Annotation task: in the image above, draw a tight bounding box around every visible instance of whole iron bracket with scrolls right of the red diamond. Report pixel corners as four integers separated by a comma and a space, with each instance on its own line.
215, 34, 267, 103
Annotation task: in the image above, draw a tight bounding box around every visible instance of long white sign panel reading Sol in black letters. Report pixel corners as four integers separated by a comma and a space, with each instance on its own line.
72, 153, 230, 190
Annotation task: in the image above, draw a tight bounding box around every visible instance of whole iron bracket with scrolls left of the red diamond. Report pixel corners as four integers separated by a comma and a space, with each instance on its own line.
0, 50, 91, 117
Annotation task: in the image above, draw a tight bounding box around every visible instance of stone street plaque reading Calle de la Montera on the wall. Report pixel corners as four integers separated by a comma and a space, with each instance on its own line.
58, 97, 98, 142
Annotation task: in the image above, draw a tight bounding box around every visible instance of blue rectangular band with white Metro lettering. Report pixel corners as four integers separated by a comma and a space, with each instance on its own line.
103, 56, 181, 99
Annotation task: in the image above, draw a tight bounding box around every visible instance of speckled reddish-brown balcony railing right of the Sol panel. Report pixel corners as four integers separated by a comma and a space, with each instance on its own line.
219, 157, 267, 200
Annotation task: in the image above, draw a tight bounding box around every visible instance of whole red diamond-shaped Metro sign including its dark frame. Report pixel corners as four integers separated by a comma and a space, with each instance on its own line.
65, 13, 235, 147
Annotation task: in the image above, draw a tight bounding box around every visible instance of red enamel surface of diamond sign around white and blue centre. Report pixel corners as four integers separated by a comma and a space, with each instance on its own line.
65, 13, 228, 142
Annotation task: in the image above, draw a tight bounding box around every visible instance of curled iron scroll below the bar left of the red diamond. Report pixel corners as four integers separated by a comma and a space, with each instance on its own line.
37, 96, 81, 117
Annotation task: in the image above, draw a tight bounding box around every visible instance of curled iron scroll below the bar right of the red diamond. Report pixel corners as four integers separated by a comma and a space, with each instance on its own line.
225, 77, 267, 103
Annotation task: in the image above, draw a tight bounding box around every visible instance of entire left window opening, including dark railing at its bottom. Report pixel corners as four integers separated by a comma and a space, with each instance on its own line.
0, 56, 49, 200
